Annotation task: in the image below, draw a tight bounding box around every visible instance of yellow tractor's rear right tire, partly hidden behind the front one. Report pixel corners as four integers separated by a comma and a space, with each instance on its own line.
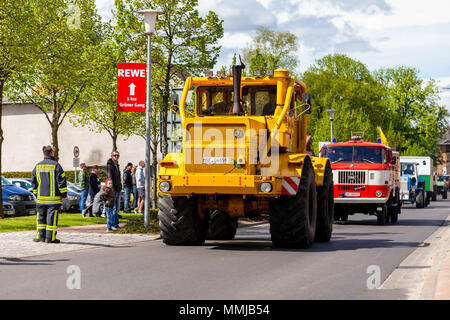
314, 162, 334, 242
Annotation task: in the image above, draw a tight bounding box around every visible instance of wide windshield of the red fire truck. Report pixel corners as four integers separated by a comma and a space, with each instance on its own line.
322, 146, 386, 163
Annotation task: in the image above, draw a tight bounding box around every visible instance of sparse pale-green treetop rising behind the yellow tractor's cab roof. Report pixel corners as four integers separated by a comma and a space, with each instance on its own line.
243, 27, 298, 73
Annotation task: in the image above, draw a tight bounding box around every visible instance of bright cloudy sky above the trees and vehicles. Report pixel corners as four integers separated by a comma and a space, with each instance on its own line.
96, 0, 450, 111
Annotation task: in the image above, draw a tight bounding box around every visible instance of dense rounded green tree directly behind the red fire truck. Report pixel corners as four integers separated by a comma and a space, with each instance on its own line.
303, 54, 386, 153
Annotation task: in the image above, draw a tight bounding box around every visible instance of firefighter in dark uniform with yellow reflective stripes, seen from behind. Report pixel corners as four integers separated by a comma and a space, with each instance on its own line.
32, 146, 67, 243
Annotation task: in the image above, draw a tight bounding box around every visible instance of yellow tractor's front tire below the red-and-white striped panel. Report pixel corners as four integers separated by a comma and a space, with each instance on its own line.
269, 158, 317, 248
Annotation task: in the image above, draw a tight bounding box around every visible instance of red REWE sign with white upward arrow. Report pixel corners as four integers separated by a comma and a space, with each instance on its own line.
117, 63, 147, 112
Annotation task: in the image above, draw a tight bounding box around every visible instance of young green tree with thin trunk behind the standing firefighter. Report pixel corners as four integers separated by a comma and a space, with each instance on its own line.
7, 0, 101, 160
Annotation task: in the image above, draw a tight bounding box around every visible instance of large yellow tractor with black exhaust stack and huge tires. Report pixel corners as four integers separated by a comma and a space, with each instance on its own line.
158, 62, 334, 248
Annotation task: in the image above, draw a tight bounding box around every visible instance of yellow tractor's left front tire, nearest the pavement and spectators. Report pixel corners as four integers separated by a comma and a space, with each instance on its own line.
158, 194, 208, 245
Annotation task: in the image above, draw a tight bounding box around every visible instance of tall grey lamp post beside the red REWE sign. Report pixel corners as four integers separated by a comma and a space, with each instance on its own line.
138, 9, 162, 227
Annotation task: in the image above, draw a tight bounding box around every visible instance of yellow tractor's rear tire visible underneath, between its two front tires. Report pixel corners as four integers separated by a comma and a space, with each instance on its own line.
206, 210, 238, 240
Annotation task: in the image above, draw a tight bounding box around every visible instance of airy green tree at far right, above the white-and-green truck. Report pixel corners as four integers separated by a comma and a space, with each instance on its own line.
375, 66, 448, 160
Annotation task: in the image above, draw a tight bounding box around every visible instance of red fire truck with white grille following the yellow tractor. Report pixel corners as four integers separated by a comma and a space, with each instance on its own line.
321, 137, 401, 225
